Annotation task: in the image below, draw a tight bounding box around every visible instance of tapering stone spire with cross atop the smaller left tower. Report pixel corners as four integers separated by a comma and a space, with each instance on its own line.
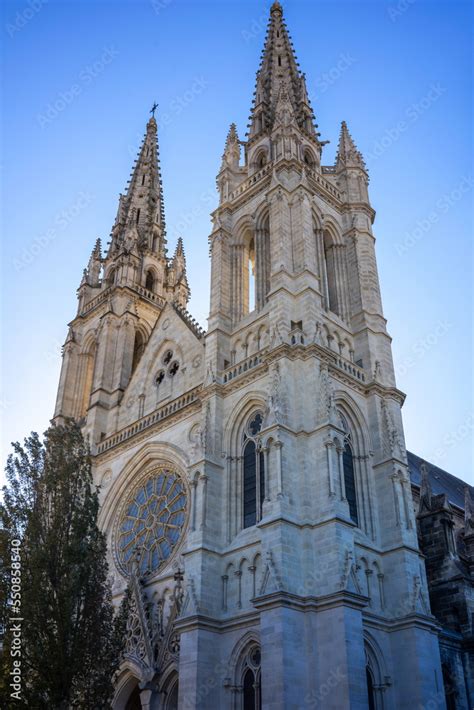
108, 116, 166, 256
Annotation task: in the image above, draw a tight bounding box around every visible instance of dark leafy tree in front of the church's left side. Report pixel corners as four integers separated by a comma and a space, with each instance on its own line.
0, 421, 128, 710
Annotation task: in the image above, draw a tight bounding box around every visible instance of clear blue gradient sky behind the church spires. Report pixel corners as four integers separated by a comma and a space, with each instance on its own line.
0, 0, 474, 482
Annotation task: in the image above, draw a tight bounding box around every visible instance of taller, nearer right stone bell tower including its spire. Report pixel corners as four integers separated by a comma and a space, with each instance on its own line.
192, 2, 444, 709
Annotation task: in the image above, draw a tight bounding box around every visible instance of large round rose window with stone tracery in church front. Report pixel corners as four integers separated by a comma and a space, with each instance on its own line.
115, 468, 187, 576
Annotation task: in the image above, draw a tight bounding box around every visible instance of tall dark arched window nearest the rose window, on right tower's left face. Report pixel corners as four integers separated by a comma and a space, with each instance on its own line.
242, 412, 265, 528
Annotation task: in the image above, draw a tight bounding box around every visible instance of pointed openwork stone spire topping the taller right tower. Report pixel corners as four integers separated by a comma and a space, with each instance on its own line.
248, 2, 319, 143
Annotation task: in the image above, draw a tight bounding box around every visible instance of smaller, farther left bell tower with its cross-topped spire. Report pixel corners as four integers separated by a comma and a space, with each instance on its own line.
55, 117, 189, 443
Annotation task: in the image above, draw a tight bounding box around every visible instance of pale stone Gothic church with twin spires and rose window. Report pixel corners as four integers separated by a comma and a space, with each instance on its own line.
55, 2, 468, 710
